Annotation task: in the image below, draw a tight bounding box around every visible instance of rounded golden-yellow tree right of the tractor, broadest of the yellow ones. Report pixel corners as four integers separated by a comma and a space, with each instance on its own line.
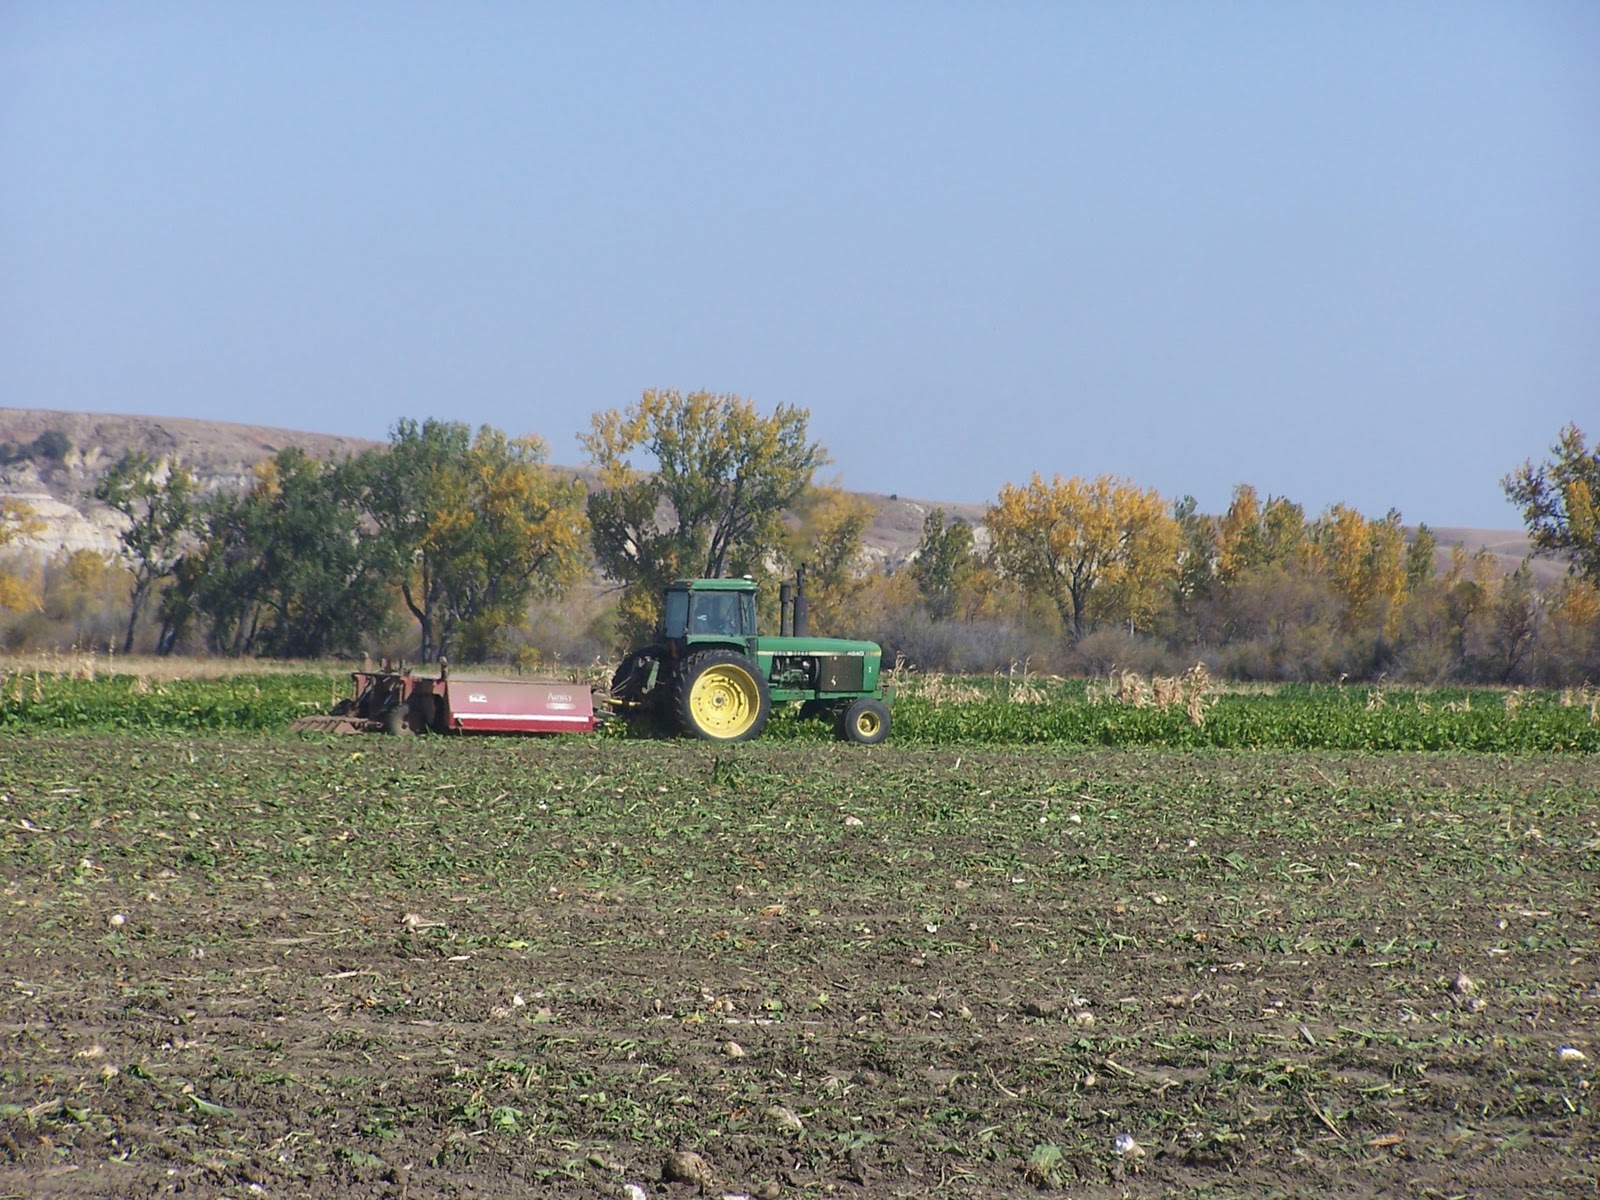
986, 474, 1179, 642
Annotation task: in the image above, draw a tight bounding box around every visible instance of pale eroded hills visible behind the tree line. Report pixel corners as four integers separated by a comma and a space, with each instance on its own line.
0, 408, 1565, 579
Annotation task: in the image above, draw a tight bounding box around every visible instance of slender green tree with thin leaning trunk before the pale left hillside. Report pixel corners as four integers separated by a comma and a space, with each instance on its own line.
94, 451, 197, 654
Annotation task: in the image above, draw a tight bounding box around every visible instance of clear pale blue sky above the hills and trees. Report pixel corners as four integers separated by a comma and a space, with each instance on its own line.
0, 0, 1600, 528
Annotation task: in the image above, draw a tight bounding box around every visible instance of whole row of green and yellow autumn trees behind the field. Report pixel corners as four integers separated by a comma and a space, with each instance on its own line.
0, 390, 1600, 682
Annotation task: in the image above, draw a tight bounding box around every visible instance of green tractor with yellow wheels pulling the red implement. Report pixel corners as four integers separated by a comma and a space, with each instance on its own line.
611, 579, 890, 746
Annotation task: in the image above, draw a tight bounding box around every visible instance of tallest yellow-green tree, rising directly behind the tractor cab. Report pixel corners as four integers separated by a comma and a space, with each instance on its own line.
579, 390, 827, 635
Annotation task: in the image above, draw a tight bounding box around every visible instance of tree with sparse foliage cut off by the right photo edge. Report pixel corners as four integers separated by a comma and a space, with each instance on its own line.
1501, 424, 1600, 586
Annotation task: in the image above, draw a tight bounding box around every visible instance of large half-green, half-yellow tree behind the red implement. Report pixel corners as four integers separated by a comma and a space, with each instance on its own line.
363, 419, 587, 662
